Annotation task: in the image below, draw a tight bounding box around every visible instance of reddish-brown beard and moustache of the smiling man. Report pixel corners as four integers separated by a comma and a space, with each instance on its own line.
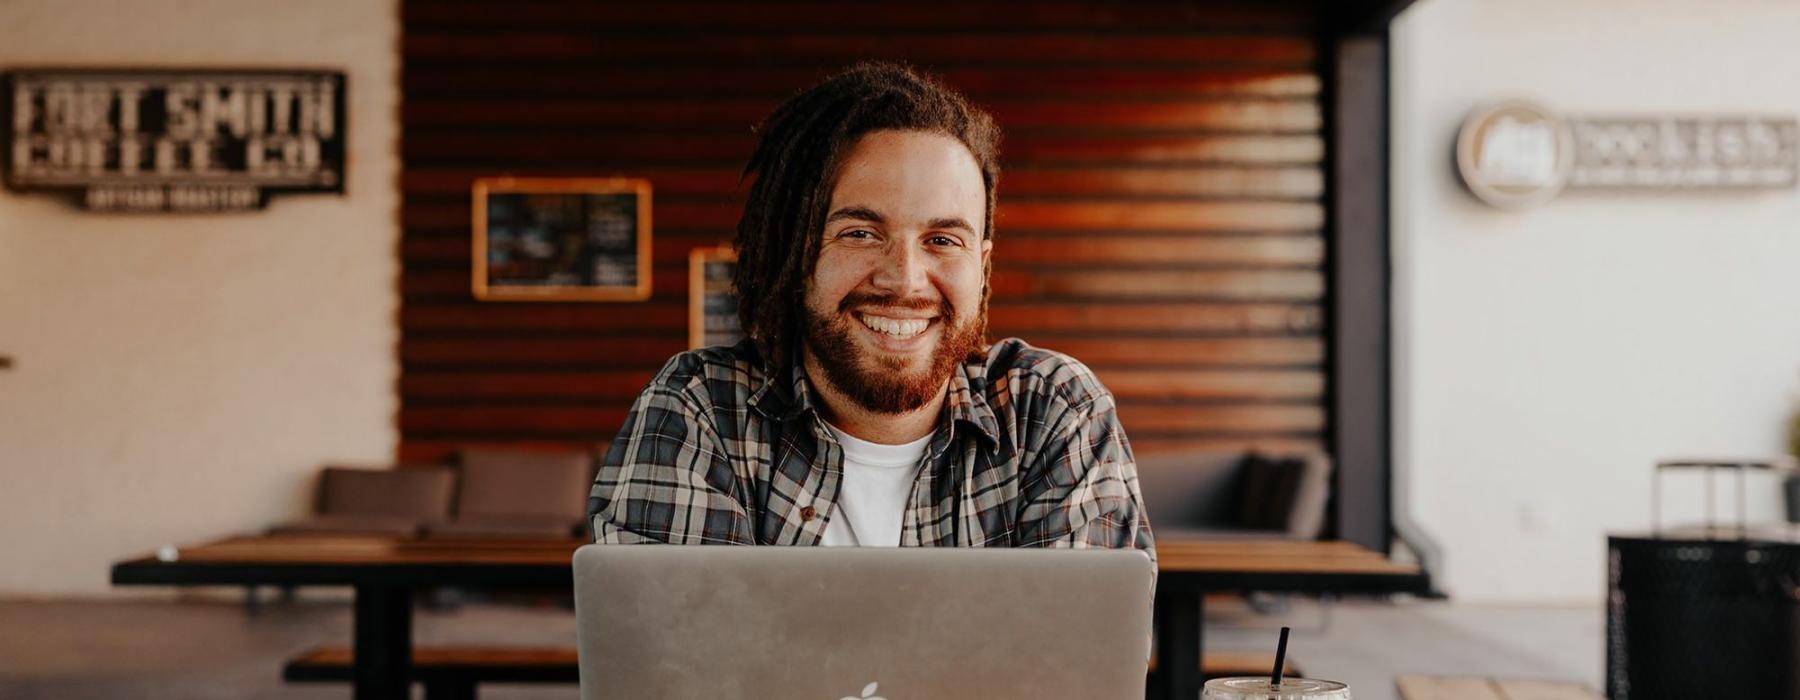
803, 292, 981, 414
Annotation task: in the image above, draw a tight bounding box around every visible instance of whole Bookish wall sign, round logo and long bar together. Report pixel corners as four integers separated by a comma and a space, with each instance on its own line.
1456, 101, 1800, 209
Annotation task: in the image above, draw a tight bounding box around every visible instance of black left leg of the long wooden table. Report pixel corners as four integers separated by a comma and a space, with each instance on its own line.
353, 583, 412, 700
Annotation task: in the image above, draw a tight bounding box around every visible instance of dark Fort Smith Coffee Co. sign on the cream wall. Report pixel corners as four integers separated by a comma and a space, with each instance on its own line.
0, 68, 344, 211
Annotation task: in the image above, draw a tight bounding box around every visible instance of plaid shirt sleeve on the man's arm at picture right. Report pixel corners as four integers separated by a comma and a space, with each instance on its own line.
1019, 392, 1156, 561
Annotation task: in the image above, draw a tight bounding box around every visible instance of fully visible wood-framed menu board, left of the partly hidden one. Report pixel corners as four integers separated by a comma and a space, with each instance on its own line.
472, 178, 650, 301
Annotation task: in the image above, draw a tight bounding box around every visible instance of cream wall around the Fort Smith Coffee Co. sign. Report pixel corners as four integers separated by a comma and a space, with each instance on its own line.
0, 0, 400, 594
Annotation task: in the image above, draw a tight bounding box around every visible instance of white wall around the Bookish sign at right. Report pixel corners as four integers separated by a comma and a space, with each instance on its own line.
1393, 0, 1800, 601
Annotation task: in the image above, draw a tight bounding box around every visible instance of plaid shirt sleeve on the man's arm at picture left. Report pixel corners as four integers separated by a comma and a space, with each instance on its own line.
587, 372, 756, 545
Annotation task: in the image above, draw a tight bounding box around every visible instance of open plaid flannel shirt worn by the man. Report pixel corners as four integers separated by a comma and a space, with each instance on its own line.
587, 338, 1156, 558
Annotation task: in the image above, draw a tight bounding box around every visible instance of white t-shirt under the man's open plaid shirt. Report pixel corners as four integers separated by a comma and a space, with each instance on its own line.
819, 423, 931, 547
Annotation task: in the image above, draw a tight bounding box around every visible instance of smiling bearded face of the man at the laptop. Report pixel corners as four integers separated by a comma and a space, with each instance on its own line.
805, 131, 992, 414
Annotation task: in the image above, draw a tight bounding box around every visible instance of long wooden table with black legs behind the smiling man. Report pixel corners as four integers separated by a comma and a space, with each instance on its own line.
112, 536, 1427, 700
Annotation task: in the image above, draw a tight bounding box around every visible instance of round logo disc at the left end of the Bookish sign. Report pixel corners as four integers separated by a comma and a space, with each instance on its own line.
1456, 101, 1575, 209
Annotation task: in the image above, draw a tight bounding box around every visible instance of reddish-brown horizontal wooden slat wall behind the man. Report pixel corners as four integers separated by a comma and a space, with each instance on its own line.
400, 0, 1327, 459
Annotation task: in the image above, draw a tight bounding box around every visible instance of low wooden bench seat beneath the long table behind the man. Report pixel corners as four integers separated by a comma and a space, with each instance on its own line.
281, 646, 1301, 700
